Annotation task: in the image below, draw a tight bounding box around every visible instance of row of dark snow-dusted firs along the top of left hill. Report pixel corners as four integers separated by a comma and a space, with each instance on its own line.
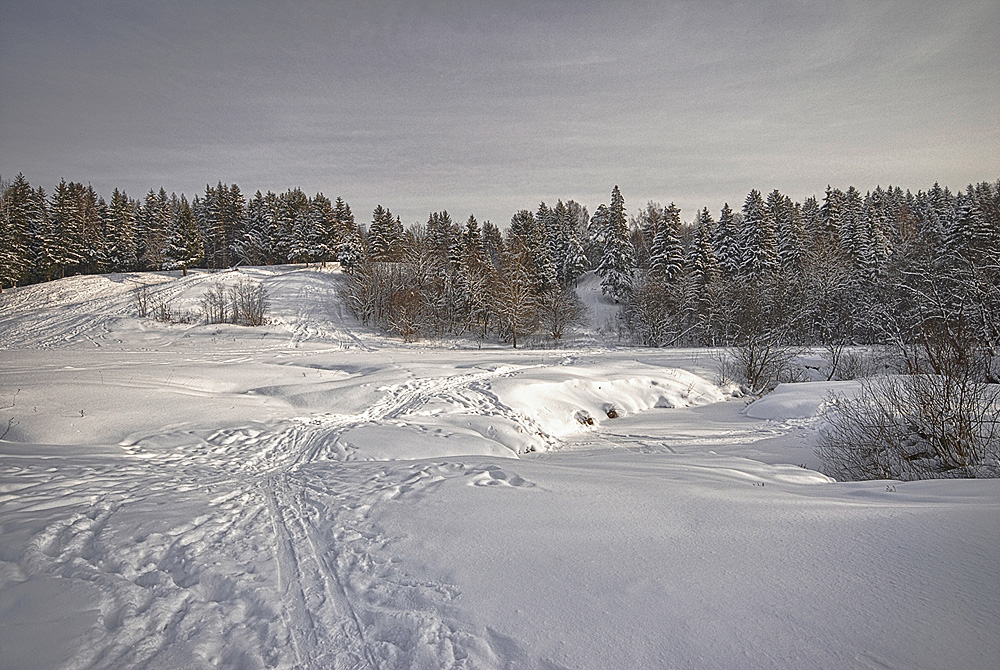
0, 174, 361, 287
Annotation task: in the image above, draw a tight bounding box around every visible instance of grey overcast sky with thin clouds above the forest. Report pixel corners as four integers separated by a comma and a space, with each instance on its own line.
0, 0, 1000, 224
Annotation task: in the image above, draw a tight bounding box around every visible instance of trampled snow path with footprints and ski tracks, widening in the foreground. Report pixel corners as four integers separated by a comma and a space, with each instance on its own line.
0, 354, 548, 670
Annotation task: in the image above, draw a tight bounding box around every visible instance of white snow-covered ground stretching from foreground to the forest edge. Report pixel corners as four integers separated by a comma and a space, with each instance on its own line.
0, 267, 1000, 669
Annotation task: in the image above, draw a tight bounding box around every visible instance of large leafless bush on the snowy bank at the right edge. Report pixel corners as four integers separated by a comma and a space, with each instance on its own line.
819, 292, 1000, 479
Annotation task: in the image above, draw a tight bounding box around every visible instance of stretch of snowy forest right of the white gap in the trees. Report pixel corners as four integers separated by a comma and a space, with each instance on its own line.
618, 182, 1000, 346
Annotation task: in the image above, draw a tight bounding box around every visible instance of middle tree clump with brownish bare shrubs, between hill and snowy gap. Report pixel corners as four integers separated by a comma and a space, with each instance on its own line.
348, 200, 599, 347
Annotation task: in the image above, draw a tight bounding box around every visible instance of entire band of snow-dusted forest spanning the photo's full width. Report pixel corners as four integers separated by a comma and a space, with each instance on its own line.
0, 174, 1000, 362
